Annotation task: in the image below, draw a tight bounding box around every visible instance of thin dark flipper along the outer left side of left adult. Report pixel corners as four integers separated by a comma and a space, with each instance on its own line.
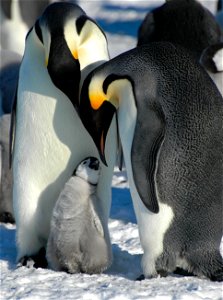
9, 85, 18, 169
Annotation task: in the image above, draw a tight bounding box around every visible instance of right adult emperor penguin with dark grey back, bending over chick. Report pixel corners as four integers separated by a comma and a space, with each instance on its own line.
80, 42, 223, 281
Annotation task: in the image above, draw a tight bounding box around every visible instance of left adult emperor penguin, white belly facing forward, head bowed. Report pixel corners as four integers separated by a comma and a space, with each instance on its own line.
12, 2, 116, 266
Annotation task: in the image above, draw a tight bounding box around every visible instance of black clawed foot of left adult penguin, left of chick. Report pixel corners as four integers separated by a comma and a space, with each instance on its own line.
17, 248, 48, 269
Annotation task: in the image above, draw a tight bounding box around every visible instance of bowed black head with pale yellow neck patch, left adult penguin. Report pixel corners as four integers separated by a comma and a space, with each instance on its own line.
28, 2, 108, 108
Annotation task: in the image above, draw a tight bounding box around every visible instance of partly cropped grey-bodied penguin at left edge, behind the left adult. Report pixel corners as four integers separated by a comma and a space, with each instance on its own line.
0, 50, 21, 223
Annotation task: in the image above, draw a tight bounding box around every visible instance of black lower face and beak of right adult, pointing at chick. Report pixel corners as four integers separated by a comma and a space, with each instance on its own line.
79, 86, 116, 166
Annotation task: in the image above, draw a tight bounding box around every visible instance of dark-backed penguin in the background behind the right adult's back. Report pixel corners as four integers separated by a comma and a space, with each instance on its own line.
137, 0, 221, 61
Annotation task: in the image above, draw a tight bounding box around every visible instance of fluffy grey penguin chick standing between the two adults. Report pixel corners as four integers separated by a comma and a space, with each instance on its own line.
47, 157, 111, 274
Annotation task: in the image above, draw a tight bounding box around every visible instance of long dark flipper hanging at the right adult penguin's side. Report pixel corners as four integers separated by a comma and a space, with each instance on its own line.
131, 108, 165, 213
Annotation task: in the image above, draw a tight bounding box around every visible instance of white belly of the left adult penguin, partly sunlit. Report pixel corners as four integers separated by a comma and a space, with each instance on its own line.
13, 81, 94, 258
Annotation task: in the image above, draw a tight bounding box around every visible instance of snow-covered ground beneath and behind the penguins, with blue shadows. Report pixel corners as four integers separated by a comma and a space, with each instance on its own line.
0, 0, 223, 300
